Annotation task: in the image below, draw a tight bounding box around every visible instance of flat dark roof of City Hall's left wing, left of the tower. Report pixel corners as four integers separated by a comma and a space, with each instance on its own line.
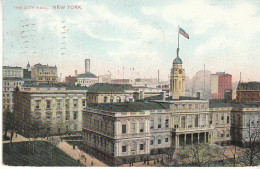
89, 102, 170, 112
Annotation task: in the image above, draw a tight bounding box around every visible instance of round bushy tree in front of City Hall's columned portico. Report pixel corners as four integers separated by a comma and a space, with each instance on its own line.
175, 144, 218, 167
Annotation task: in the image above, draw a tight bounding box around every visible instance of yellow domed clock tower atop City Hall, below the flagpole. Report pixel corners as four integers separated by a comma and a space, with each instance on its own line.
169, 48, 185, 99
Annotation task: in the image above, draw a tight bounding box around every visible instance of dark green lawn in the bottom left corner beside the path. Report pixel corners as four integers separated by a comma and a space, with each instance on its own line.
3, 141, 83, 166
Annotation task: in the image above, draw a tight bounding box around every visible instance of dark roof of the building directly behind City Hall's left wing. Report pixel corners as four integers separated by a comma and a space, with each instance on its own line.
88, 83, 134, 93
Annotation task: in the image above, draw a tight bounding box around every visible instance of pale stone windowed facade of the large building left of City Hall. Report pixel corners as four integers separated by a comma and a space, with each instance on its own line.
15, 87, 87, 137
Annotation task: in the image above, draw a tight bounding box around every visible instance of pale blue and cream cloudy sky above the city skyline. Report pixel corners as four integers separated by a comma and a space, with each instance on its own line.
3, 0, 260, 82
